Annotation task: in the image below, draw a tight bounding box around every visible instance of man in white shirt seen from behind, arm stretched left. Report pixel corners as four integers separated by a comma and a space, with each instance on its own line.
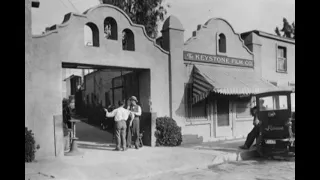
104, 101, 134, 151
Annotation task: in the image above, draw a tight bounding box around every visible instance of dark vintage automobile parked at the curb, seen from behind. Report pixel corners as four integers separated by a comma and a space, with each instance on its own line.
256, 90, 295, 156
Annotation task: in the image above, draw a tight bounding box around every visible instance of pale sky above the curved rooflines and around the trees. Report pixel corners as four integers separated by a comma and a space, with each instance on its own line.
32, 0, 295, 40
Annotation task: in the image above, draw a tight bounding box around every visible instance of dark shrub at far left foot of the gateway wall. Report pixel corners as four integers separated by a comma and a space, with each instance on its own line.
24, 127, 36, 162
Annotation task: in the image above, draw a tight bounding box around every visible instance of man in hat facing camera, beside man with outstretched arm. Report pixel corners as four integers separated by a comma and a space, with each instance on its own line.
130, 96, 142, 149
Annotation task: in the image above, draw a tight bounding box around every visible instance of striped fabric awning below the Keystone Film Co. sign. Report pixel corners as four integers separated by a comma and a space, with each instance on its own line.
192, 65, 278, 103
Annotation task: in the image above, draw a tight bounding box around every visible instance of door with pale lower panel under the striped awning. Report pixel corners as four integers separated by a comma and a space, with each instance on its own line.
216, 98, 232, 137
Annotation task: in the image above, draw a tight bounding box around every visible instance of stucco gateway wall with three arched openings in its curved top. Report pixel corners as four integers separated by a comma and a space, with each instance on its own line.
25, 4, 183, 157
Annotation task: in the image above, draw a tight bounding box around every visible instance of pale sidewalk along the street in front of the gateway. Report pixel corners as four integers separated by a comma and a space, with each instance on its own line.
25, 146, 240, 180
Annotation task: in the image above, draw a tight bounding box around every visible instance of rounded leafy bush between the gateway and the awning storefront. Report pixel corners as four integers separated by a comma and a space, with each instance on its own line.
155, 117, 182, 146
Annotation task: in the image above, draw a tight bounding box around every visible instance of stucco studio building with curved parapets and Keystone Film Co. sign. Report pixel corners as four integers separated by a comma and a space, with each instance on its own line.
25, 0, 294, 157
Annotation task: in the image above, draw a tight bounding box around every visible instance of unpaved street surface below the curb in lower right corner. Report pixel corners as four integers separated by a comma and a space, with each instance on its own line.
143, 160, 295, 180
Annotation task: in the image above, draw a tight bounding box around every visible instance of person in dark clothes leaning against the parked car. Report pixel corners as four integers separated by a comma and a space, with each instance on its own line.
239, 106, 261, 149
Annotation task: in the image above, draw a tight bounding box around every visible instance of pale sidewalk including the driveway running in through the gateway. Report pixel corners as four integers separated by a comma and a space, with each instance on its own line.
25, 120, 258, 180
